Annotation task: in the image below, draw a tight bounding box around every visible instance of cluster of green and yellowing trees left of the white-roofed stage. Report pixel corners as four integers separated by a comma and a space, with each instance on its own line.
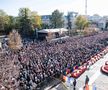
0, 8, 42, 36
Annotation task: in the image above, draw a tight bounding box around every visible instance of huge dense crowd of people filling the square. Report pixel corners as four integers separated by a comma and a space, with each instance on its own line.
0, 32, 108, 90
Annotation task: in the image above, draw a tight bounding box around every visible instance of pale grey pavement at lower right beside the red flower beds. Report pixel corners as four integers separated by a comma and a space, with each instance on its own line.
65, 54, 108, 90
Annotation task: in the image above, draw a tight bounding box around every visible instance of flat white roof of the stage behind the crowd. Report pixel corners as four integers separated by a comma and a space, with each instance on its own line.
37, 28, 68, 33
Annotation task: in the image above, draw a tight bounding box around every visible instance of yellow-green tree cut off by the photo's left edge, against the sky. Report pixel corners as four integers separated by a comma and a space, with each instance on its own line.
0, 10, 18, 34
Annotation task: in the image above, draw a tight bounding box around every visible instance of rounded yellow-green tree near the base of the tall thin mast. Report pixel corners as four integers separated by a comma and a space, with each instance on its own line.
75, 15, 89, 30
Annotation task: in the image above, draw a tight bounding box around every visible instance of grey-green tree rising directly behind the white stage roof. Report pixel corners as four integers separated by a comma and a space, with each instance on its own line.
50, 10, 64, 28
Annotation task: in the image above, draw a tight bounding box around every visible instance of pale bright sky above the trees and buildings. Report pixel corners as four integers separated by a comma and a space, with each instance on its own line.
0, 0, 108, 16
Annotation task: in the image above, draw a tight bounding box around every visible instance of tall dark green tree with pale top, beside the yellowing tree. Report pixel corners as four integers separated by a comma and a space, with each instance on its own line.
19, 8, 33, 36
